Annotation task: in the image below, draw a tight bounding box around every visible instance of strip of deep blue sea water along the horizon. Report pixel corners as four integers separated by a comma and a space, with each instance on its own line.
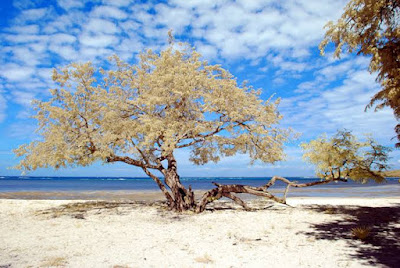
0, 176, 400, 196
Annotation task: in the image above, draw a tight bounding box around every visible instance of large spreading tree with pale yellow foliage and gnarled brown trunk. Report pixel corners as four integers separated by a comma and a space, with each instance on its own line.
15, 39, 288, 212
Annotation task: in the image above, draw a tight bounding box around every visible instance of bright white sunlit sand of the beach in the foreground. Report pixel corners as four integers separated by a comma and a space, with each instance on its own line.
0, 198, 400, 267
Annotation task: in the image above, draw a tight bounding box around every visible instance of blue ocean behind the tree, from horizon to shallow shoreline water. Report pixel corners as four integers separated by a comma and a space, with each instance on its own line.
0, 176, 400, 199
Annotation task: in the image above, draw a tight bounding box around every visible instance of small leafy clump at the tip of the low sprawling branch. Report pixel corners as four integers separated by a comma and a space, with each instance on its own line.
301, 130, 390, 183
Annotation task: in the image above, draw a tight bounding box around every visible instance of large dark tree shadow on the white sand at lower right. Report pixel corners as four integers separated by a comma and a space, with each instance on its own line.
305, 204, 400, 267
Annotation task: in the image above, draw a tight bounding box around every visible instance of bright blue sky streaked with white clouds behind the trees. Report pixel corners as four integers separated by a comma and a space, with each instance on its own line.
0, 0, 400, 177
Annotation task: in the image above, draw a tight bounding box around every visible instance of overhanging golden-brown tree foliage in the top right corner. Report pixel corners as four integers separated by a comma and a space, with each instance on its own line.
320, 0, 400, 147
